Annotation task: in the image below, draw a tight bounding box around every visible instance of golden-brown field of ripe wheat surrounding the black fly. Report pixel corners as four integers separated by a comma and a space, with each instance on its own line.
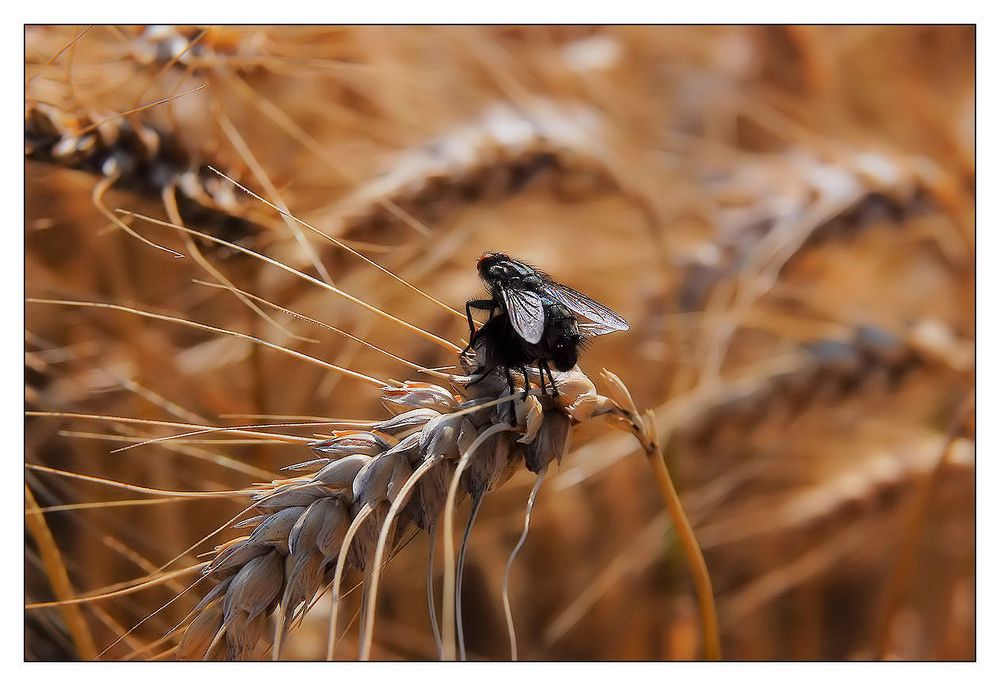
24, 25, 976, 661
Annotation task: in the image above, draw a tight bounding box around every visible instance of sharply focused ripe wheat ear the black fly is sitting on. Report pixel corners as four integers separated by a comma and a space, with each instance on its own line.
177, 357, 635, 660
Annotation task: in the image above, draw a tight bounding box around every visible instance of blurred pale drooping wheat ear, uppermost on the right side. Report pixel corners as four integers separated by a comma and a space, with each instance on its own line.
680, 150, 941, 310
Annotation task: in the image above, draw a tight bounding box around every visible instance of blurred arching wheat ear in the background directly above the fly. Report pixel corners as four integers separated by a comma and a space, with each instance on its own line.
337, 99, 621, 238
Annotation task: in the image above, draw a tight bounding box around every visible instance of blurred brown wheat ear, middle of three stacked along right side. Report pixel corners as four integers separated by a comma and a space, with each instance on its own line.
677, 321, 971, 445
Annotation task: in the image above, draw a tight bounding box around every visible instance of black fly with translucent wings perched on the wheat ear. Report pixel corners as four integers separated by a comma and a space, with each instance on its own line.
465, 253, 628, 404
